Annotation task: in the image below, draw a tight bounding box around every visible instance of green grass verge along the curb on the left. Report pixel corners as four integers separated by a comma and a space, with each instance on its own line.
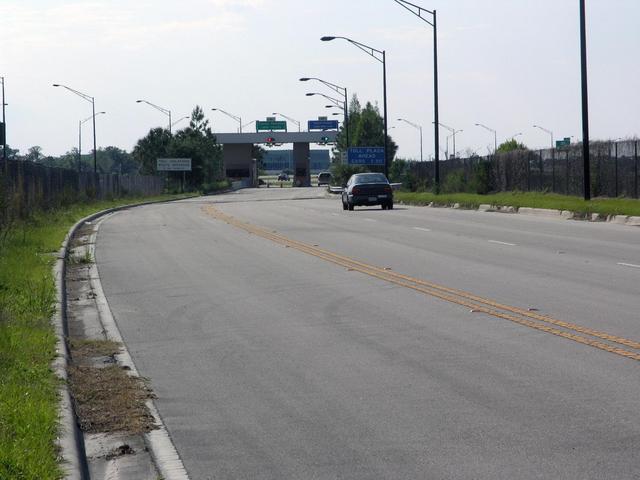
0, 196, 196, 480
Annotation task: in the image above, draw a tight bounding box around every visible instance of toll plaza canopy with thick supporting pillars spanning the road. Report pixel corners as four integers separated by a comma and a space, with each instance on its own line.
215, 130, 338, 187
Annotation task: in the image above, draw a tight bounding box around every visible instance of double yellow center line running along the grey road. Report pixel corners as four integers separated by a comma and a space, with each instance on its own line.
203, 205, 640, 361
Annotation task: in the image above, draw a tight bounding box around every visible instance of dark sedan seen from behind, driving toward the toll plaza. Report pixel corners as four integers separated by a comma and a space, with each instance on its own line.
342, 173, 393, 210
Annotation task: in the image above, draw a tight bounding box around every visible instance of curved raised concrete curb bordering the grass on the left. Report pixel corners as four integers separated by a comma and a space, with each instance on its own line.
51, 195, 200, 480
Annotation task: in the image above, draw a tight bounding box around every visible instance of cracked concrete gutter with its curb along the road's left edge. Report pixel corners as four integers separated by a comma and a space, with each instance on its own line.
52, 197, 195, 480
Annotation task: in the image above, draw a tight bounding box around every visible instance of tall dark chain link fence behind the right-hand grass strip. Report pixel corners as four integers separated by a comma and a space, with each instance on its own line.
408, 140, 640, 198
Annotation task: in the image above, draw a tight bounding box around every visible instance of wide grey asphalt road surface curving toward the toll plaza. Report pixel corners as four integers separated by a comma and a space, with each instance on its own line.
96, 188, 640, 480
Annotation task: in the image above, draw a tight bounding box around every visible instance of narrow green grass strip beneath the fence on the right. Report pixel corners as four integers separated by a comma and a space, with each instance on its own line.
394, 192, 640, 216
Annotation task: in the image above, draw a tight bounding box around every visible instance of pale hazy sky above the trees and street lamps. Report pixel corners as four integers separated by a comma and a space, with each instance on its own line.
0, 0, 640, 159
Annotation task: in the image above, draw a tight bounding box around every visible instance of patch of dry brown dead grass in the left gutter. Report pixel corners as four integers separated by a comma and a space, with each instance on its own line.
69, 365, 157, 433
